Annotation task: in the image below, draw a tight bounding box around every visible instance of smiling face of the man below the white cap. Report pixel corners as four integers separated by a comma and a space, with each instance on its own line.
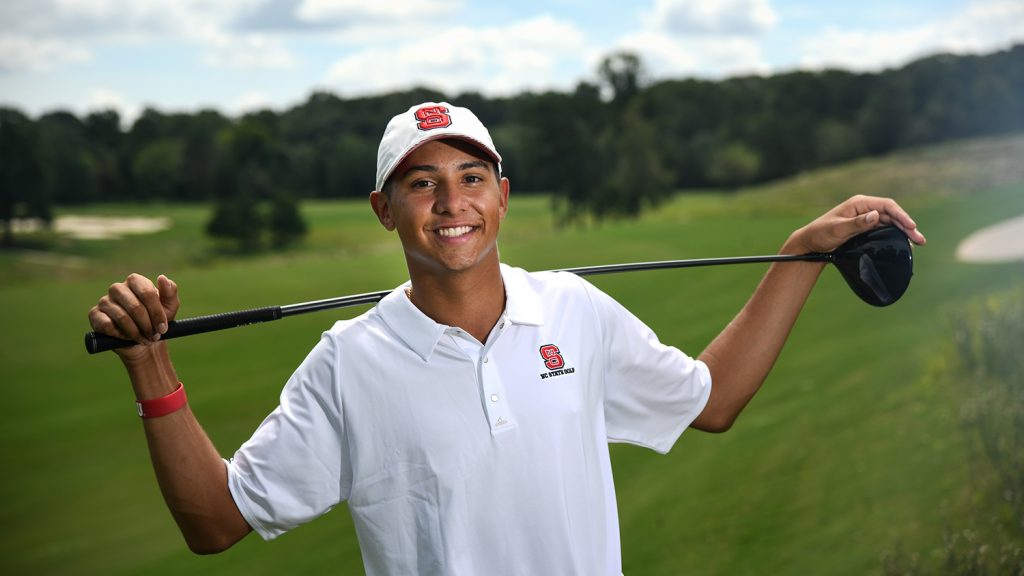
370, 139, 509, 278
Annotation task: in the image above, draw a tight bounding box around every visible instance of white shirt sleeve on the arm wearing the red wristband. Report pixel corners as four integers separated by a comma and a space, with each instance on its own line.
225, 333, 351, 540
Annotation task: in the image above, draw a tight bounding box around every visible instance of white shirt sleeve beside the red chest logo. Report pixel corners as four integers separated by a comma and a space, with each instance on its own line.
584, 282, 711, 454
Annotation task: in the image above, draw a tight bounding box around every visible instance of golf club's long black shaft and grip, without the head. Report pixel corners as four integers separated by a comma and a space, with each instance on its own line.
85, 252, 833, 354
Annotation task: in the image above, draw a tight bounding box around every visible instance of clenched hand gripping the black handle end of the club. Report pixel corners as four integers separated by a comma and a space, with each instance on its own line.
89, 274, 181, 361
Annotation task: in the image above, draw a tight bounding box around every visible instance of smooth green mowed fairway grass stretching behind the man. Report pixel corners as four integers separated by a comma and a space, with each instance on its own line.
6, 133, 1024, 576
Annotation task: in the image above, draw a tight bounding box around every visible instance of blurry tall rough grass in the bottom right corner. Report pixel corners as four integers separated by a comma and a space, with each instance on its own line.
882, 287, 1024, 576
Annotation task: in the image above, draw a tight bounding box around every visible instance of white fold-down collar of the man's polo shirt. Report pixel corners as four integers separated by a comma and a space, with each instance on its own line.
377, 264, 544, 362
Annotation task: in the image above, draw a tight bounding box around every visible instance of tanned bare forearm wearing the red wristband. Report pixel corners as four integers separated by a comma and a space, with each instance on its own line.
125, 343, 250, 553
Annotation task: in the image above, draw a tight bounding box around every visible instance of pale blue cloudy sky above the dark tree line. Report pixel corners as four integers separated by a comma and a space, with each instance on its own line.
0, 0, 1024, 120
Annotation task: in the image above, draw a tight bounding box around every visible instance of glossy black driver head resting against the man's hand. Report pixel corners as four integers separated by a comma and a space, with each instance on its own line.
831, 227, 913, 306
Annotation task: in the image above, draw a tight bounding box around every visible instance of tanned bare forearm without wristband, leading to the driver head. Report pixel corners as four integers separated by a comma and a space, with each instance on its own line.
692, 234, 825, 431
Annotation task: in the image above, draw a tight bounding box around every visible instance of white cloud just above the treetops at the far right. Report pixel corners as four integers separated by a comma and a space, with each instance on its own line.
800, 0, 1024, 70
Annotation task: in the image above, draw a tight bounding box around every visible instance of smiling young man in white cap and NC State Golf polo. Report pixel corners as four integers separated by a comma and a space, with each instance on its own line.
89, 102, 925, 575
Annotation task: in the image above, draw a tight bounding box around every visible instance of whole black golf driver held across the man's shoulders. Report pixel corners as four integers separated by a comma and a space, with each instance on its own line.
85, 227, 913, 354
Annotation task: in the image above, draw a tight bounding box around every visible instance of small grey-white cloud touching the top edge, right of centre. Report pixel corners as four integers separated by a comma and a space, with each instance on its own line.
647, 0, 778, 36
